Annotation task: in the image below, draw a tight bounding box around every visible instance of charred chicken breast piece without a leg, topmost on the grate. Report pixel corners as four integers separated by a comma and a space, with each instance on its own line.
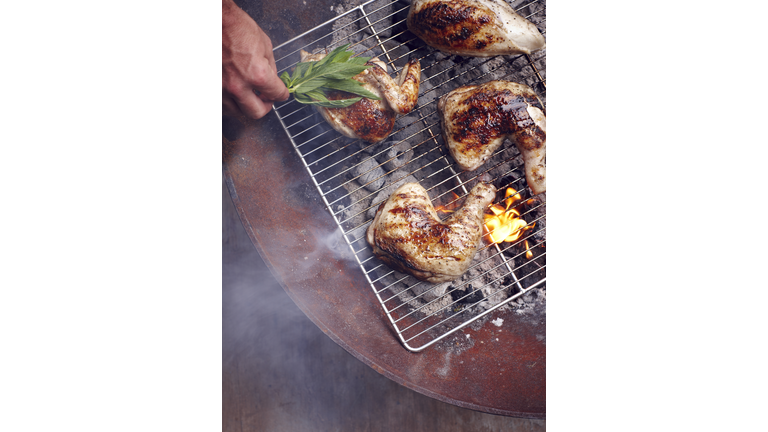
407, 0, 546, 57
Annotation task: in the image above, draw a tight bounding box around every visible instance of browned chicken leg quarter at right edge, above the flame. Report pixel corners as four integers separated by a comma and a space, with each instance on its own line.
437, 81, 547, 194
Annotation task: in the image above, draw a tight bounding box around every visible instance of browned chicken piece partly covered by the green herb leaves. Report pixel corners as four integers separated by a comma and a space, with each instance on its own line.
300, 50, 421, 143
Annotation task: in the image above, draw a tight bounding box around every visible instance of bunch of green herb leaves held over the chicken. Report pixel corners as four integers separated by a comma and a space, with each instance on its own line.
280, 44, 380, 108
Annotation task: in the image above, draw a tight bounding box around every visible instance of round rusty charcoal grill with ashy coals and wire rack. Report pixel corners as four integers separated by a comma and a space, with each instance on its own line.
223, 0, 546, 418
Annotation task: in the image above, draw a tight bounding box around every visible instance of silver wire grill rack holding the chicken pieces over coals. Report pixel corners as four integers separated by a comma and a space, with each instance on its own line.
274, 0, 546, 352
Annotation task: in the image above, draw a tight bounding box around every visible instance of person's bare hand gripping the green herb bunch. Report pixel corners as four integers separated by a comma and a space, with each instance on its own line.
221, 0, 289, 119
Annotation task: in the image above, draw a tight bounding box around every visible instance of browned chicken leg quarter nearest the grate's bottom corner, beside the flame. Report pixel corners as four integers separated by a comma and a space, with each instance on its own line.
366, 183, 496, 283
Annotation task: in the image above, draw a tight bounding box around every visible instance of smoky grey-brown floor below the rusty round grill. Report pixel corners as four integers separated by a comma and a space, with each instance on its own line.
222, 177, 546, 432
